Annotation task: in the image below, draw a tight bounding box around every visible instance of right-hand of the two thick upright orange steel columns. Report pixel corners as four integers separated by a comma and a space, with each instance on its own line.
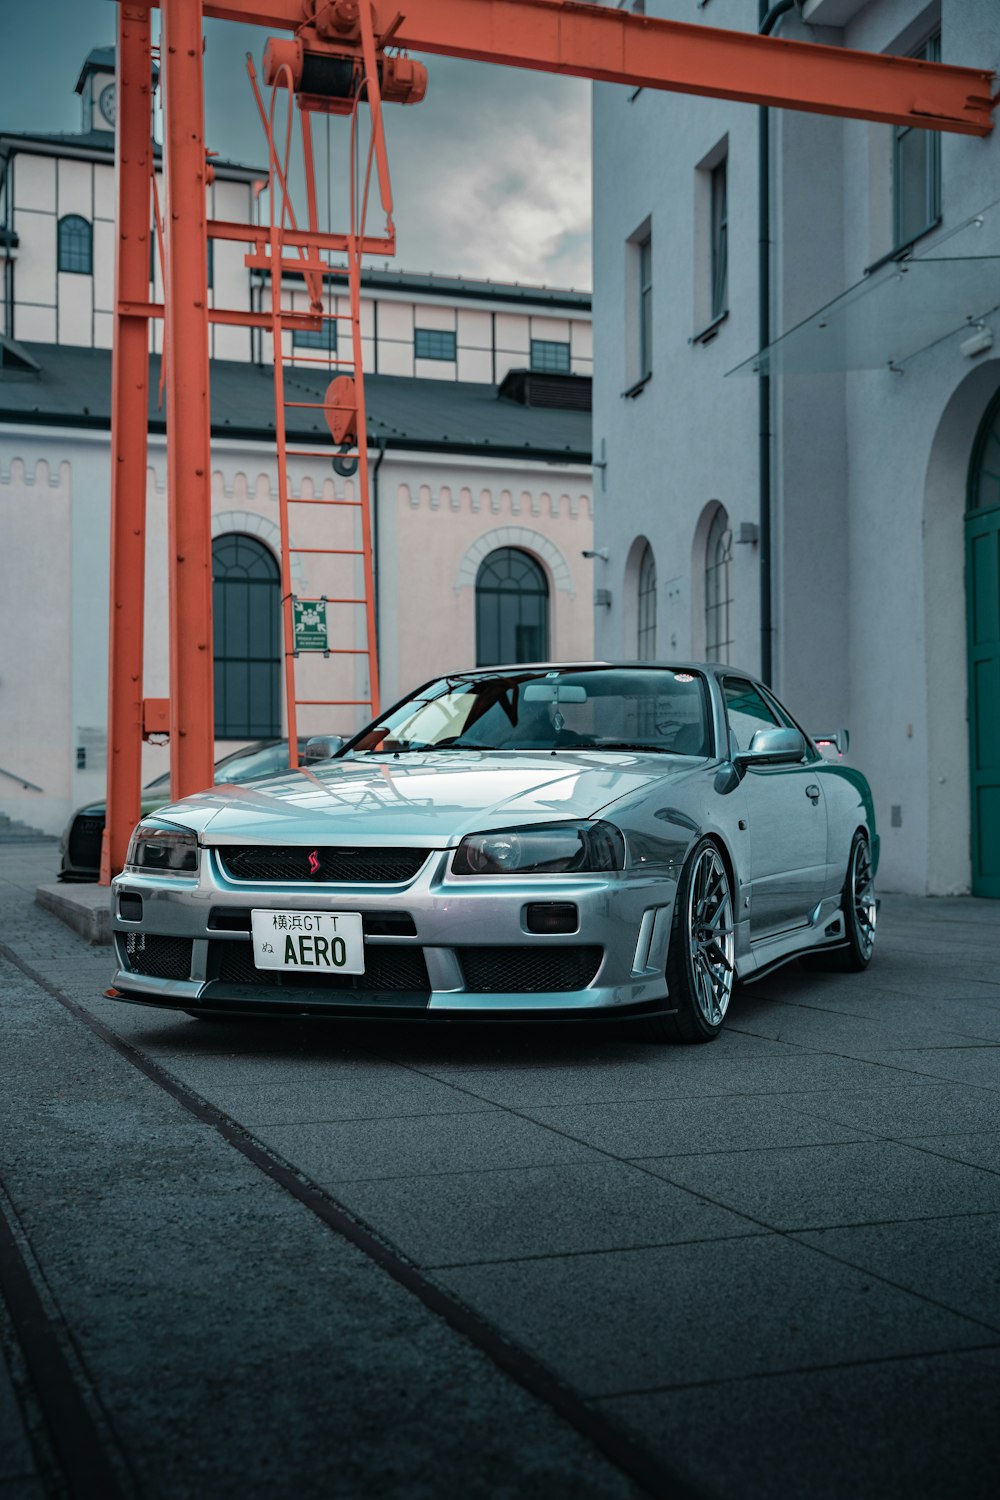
160, 0, 214, 800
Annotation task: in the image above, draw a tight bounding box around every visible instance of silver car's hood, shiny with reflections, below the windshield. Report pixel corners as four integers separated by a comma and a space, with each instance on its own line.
162, 750, 703, 848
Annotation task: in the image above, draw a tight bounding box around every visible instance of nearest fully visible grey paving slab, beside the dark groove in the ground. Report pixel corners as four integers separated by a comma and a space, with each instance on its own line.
439, 1235, 994, 1398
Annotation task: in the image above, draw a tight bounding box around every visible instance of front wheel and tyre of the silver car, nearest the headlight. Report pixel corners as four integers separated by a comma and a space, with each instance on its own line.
646, 839, 736, 1043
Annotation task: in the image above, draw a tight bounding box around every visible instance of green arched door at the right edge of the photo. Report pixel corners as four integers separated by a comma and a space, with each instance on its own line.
966, 396, 1000, 899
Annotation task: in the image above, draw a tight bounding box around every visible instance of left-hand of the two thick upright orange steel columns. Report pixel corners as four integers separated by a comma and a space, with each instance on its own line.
100, 3, 153, 885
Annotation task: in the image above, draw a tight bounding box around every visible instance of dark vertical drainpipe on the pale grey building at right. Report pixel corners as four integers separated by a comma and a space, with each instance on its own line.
757, 0, 796, 686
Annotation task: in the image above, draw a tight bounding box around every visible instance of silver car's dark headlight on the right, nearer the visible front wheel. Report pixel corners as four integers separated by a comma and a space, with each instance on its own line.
451, 822, 625, 875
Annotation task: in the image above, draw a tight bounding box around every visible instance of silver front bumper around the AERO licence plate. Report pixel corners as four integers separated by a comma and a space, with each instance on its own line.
111, 851, 675, 1020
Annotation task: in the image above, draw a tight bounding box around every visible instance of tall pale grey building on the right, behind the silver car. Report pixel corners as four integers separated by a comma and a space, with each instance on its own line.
594, 0, 1000, 897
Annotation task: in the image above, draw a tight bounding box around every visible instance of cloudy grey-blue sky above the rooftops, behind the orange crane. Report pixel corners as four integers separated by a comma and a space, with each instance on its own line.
0, 0, 591, 288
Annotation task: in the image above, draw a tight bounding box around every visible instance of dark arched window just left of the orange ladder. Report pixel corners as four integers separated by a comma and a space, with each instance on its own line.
211, 534, 282, 740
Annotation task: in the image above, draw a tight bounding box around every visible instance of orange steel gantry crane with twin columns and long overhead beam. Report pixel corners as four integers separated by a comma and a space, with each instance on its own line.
100, 0, 997, 884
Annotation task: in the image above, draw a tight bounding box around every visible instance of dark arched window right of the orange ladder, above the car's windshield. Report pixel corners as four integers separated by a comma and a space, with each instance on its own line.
475, 548, 549, 666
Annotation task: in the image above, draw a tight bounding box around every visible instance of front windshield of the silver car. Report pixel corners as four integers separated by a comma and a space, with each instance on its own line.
346, 668, 709, 756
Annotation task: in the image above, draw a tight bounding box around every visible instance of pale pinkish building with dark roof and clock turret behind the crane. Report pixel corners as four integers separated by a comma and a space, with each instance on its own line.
0, 48, 594, 831
